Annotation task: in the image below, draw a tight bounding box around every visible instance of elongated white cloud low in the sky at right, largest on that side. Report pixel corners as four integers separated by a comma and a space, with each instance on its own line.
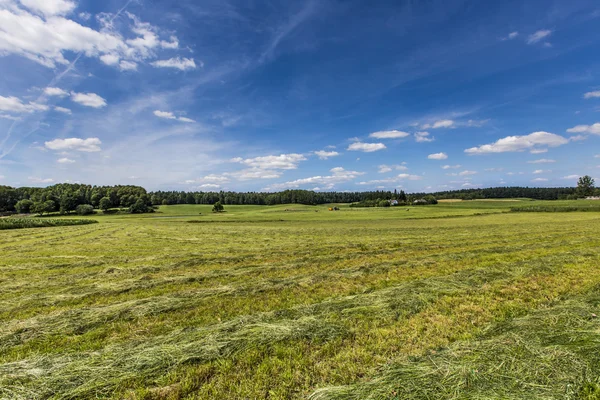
465, 131, 569, 154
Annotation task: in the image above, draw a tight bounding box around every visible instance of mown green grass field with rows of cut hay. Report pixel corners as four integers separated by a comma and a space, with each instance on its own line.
0, 201, 600, 400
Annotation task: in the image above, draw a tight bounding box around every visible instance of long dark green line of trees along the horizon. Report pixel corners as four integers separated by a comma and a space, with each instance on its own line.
0, 176, 600, 214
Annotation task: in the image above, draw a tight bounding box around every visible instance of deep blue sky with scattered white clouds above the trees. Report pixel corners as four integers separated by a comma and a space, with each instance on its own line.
0, 0, 600, 192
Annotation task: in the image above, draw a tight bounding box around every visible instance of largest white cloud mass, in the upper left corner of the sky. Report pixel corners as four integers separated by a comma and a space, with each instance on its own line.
0, 0, 185, 70
